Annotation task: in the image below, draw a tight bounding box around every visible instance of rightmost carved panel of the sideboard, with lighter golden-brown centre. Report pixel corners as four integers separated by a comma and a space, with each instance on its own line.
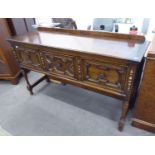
84, 60, 127, 93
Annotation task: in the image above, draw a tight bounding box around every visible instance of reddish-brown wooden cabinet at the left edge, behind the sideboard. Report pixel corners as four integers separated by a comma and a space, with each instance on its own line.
0, 18, 20, 84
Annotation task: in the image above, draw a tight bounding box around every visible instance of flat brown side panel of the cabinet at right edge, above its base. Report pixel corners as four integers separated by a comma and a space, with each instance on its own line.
134, 57, 155, 131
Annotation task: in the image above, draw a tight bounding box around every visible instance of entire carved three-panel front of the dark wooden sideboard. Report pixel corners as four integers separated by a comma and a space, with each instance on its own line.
12, 45, 136, 96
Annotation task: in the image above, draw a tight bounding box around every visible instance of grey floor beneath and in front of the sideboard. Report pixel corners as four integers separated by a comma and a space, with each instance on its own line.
0, 72, 154, 136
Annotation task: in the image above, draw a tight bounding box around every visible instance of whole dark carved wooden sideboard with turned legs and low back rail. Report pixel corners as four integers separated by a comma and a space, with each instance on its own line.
8, 27, 149, 130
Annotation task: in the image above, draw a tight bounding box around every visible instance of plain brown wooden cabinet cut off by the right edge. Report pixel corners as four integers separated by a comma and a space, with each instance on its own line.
132, 36, 155, 132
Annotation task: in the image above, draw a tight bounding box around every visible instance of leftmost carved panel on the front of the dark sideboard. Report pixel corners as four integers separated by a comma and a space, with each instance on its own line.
15, 46, 42, 70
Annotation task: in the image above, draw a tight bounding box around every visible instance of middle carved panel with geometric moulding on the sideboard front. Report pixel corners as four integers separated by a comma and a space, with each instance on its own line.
40, 51, 75, 79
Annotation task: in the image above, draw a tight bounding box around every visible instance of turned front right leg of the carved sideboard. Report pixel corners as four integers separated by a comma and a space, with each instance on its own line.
118, 101, 129, 131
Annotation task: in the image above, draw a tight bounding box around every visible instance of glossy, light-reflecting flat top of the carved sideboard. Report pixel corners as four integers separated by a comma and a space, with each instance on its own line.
8, 27, 149, 62
